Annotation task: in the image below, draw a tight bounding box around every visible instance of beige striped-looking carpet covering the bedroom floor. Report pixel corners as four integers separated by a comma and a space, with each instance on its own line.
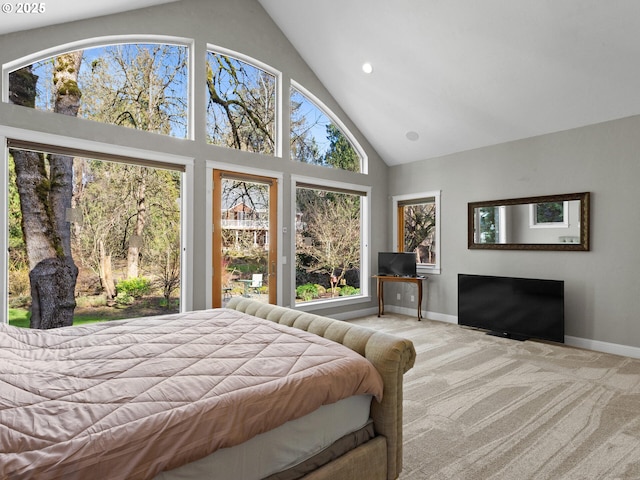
353, 314, 640, 480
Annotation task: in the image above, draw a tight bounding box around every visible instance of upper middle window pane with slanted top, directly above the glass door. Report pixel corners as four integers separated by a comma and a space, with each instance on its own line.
207, 52, 276, 155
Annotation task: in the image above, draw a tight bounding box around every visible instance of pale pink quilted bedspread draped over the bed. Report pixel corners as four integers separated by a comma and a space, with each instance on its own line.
0, 309, 382, 480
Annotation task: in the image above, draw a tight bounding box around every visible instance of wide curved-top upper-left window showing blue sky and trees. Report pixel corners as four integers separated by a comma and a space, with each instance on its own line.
9, 43, 189, 138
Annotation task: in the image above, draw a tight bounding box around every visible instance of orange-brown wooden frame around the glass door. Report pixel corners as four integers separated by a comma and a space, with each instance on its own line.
211, 168, 278, 308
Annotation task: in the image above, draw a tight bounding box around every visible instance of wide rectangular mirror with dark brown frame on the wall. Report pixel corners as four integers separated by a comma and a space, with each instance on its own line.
468, 192, 590, 252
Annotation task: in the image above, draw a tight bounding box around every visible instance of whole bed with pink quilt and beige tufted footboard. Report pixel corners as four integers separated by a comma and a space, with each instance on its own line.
0, 298, 415, 480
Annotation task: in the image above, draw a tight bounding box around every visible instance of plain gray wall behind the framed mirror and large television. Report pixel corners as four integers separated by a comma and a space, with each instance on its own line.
389, 116, 640, 347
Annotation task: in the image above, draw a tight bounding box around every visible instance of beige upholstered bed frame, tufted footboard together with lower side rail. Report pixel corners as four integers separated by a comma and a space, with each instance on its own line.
227, 297, 416, 480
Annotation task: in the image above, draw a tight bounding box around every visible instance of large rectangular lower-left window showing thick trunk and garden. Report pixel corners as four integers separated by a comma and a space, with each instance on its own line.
8, 141, 182, 328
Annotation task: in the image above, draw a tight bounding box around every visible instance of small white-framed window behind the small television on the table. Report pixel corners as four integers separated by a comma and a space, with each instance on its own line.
393, 192, 440, 274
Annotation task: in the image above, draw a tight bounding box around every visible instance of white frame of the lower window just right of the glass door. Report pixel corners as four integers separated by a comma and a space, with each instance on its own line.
289, 175, 372, 311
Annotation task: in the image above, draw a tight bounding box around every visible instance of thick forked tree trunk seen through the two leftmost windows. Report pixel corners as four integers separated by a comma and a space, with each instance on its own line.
9, 51, 82, 329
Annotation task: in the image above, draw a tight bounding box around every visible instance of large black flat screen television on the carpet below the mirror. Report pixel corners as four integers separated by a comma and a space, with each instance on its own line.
458, 273, 564, 343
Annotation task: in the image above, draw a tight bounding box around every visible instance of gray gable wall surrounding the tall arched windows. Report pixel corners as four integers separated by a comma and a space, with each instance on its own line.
0, 0, 388, 313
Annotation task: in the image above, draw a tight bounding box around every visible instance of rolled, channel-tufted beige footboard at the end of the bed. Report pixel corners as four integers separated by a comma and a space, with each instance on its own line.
227, 297, 416, 480
